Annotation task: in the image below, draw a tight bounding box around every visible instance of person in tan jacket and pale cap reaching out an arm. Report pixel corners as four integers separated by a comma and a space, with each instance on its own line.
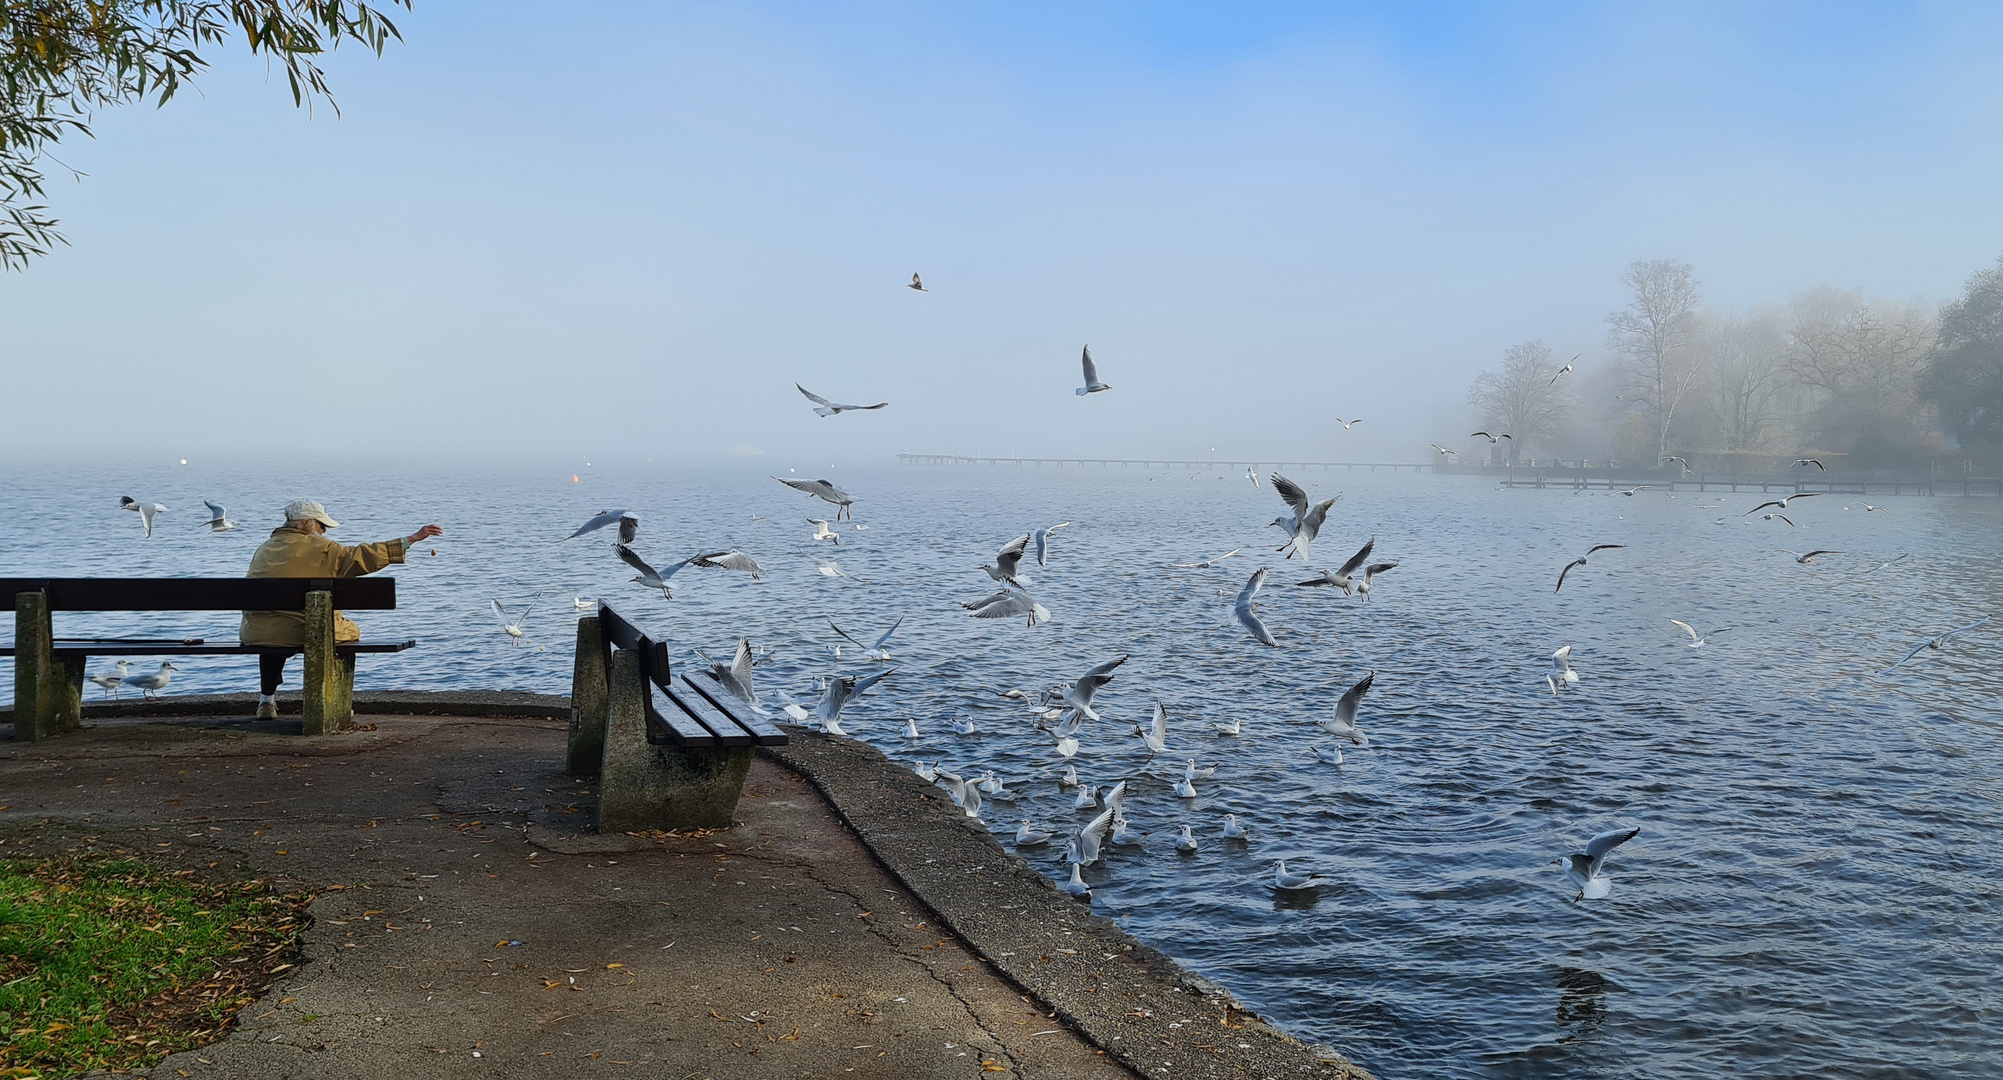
236, 499, 445, 719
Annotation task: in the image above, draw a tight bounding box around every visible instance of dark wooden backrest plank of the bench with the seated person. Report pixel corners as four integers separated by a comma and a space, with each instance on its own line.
0, 577, 397, 611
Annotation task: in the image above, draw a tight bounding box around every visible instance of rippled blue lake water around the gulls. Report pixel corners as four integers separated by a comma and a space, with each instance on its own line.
0, 469, 2003, 1078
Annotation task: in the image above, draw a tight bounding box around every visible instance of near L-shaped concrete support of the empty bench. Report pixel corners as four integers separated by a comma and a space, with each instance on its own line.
599, 649, 755, 832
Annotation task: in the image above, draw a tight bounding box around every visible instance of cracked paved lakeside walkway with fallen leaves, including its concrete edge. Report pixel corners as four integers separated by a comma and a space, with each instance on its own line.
0, 703, 1368, 1080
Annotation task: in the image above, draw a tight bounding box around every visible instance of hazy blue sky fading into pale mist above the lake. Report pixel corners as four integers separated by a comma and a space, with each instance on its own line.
0, 0, 2003, 467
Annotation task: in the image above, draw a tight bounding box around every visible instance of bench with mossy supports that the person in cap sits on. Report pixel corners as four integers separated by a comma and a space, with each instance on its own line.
0, 577, 417, 741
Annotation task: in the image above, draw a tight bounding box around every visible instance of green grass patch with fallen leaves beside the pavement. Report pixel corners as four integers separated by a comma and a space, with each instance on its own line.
0, 854, 310, 1080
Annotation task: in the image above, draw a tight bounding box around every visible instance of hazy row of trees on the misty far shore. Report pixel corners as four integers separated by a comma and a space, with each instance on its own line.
1468, 258, 2003, 473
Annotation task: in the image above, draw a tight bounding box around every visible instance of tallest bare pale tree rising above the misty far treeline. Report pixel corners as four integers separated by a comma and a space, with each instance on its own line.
1606, 258, 1703, 461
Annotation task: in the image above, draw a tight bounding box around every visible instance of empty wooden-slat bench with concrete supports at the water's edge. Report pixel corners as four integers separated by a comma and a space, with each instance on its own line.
569, 605, 787, 832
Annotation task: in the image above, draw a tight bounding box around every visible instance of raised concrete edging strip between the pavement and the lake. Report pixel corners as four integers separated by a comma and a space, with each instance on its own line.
0, 691, 1370, 1080
